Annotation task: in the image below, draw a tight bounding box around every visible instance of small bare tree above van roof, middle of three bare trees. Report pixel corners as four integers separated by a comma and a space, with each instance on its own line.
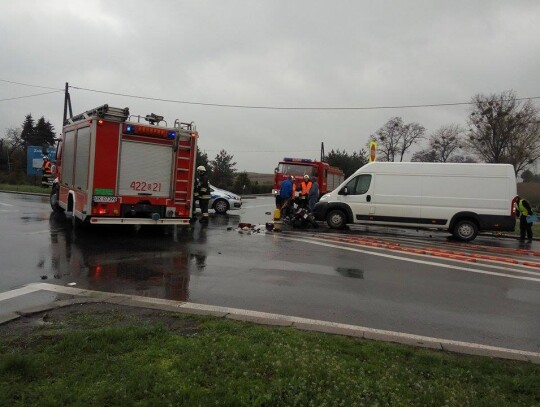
411, 124, 463, 163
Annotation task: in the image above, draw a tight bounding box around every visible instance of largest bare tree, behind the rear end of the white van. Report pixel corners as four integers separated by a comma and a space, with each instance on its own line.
467, 91, 540, 174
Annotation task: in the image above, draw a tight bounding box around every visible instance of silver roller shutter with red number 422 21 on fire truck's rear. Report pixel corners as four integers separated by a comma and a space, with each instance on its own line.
118, 140, 172, 197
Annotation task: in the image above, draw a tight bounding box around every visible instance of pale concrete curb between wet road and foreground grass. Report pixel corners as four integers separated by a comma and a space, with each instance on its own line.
0, 283, 540, 364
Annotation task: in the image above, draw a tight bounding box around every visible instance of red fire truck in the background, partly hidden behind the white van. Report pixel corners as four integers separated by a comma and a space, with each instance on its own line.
272, 157, 344, 196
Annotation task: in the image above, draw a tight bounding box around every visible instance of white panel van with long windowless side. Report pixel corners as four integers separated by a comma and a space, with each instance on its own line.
314, 162, 517, 241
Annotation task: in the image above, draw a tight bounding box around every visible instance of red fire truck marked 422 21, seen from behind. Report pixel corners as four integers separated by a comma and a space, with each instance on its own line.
50, 84, 198, 225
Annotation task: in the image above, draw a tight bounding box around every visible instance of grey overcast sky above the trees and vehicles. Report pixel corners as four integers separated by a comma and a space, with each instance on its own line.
0, 0, 540, 173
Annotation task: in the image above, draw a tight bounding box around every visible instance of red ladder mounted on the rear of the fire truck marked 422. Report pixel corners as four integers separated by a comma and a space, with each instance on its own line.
174, 120, 197, 207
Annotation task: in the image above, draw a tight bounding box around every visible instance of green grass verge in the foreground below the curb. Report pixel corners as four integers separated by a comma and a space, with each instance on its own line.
0, 313, 540, 407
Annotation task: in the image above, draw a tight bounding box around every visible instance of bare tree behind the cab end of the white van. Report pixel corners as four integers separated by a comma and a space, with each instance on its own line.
370, 117, 426, 161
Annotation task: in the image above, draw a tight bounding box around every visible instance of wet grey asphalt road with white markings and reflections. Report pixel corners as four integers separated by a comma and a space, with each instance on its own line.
0, 193, 540, 352
